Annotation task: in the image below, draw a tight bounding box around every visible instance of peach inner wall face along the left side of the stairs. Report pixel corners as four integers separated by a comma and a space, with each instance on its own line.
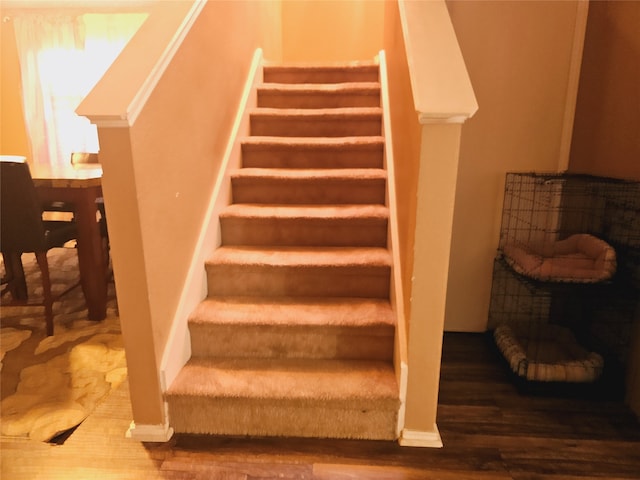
131, 2, 268, 364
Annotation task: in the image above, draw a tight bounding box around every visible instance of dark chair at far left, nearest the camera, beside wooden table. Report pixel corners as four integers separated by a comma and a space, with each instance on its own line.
0, 162, 78, 335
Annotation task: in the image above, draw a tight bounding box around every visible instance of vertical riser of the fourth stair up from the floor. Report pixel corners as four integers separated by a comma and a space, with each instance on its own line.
220, 217, 387, 247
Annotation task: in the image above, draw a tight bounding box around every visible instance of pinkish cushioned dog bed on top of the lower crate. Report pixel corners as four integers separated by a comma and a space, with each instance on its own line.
503, 233, 616, 283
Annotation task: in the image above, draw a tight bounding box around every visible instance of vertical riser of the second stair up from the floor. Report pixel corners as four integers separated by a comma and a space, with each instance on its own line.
189, 323, 393, 361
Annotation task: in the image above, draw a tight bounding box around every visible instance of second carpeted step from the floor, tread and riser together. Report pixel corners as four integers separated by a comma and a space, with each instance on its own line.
189, 297, 395, 361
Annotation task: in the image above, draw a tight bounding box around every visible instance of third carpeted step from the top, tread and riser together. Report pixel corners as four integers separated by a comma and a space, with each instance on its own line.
249, 107, 382, 137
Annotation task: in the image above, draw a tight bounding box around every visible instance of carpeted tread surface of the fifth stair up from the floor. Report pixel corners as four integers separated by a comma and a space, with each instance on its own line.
231, 167, 387, 181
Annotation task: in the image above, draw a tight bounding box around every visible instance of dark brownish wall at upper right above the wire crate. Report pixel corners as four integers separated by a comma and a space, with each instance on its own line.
569, 1, 640, 179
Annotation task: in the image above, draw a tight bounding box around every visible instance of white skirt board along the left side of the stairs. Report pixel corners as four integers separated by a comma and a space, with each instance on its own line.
160, 48, 264, 400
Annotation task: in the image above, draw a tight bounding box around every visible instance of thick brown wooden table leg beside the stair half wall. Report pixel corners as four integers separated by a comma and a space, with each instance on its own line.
75, 189, 107, 320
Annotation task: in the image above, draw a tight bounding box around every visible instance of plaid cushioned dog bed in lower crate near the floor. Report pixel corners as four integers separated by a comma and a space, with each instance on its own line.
493, 324, 604, 383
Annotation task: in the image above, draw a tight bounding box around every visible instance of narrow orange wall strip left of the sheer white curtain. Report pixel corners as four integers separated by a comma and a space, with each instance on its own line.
0, 17, 30, 157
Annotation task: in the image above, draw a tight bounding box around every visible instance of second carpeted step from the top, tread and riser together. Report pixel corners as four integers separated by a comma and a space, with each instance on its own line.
258, 82, 380, 108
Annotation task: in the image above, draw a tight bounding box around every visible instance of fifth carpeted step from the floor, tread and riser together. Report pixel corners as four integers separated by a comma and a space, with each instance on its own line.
231, 168, 387, 205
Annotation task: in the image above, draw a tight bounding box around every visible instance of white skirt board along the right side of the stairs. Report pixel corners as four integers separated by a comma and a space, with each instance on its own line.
378, 50, 409, 438
